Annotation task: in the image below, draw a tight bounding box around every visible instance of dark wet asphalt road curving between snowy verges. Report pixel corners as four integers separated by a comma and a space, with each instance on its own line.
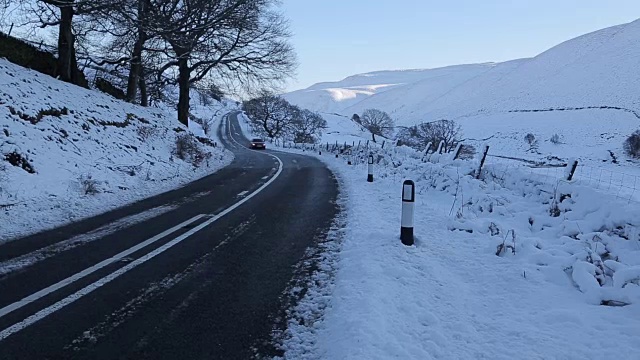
0, 114, 337, 360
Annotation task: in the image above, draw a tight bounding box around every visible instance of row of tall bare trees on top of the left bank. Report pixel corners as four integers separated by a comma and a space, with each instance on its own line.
0, 0, 296, 124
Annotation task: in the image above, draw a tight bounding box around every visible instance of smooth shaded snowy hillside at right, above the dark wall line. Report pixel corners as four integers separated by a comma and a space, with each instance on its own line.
413, 20, 640, 121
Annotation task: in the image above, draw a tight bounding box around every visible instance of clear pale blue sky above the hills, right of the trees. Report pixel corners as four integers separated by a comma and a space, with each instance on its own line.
281, 0, 640, 90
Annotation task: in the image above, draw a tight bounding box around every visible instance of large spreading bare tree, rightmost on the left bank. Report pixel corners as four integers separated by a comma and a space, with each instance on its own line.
150, 0, 295, 124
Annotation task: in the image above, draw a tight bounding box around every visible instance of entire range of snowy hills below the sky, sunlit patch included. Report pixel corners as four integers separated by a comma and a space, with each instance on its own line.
284, 20, 640, 125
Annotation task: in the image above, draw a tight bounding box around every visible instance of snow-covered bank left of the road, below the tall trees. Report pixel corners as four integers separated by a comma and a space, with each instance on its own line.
0, 60, 232, 242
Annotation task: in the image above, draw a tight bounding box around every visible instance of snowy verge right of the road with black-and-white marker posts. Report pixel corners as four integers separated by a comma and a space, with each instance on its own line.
272, 144, 640, 359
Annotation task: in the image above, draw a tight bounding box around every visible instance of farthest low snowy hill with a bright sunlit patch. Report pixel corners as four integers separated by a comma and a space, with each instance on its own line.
283, 64, 493, 113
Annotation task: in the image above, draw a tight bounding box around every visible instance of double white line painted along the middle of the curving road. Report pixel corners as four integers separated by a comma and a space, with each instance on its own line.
0, 114, 283, 341
